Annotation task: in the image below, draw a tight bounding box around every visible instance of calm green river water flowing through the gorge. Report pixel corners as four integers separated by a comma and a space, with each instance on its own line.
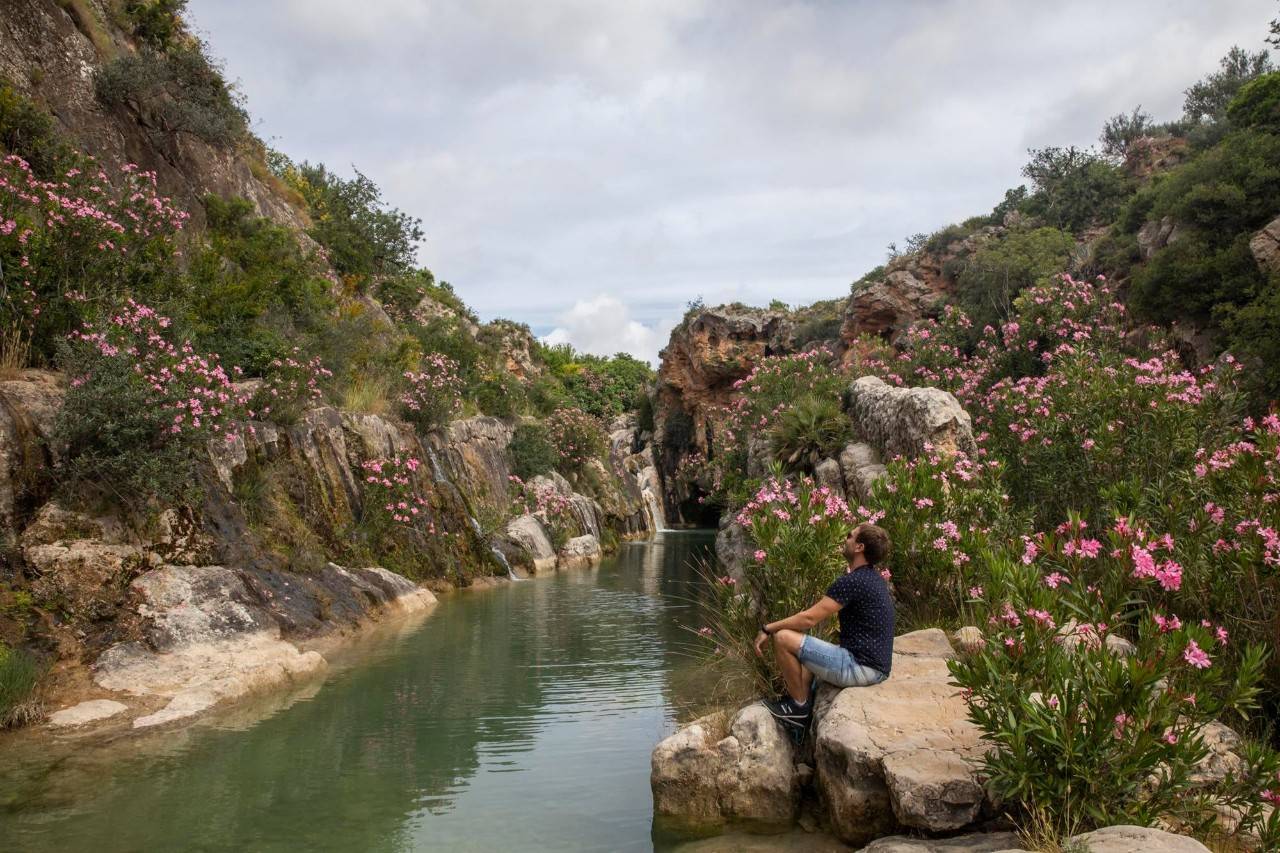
0, 533, 713, 853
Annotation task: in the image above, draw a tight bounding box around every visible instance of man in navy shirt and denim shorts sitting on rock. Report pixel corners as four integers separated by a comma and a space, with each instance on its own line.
755, 524, 893, 736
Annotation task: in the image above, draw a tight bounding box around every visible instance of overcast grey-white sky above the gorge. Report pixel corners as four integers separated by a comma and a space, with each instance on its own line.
189, 0, 1277, 359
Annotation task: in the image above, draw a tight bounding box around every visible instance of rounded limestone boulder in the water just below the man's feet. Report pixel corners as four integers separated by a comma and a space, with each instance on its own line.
650, 703, 800, 829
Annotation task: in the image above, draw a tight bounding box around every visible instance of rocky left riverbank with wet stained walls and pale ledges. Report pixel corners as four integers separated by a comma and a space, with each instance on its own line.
0, 370, 663, 727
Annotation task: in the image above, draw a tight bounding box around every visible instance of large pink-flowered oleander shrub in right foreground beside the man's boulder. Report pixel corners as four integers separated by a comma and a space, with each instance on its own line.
950, 532, 1263, 835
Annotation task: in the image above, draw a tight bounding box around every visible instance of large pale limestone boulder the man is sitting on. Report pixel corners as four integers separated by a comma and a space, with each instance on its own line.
814, 629, 984, 844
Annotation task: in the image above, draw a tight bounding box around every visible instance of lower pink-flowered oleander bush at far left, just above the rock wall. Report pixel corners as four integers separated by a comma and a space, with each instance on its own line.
55, 301, 244, 505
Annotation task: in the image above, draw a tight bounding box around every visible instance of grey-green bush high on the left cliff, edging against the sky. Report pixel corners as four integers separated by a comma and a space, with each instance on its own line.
95, 45, 248, 147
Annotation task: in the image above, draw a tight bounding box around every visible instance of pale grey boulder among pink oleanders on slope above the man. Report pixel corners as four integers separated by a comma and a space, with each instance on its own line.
849, 377, 977, 457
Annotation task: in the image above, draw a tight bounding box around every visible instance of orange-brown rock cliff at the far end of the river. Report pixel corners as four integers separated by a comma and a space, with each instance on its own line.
654, 305, 794, 524
